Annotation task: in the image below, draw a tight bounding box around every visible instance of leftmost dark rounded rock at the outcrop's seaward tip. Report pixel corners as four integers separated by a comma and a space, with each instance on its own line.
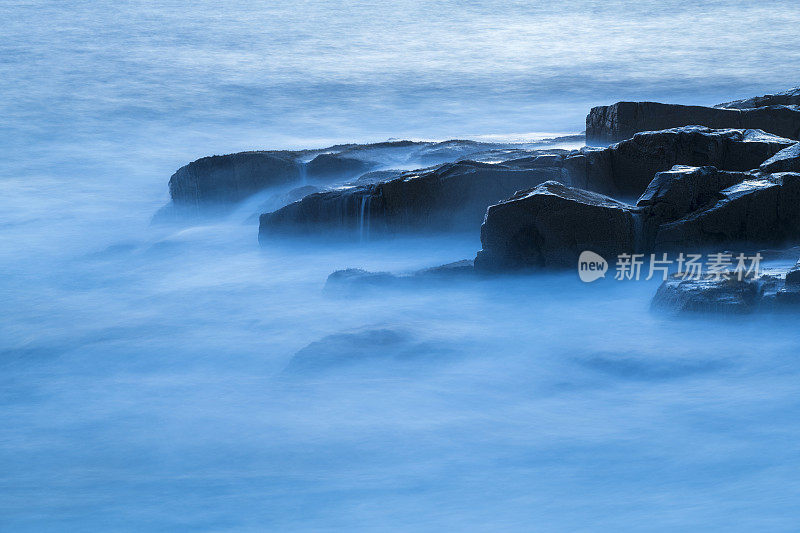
169, 152, 300, 207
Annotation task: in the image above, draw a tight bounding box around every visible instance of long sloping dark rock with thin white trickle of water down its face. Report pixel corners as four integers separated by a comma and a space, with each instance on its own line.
259, 161, 564, 239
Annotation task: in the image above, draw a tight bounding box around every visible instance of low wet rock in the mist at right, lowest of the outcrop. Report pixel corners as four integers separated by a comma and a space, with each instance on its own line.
651, 264, 800, 314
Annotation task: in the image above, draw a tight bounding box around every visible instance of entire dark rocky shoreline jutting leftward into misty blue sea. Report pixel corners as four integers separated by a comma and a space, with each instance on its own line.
158, 89, 800, 312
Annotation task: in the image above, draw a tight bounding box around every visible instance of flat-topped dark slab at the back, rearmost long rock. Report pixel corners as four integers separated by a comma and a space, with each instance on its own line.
586, 102, 800, 145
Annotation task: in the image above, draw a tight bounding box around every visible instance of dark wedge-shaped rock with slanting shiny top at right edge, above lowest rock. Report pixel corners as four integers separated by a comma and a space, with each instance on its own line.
655, 173, 800, 249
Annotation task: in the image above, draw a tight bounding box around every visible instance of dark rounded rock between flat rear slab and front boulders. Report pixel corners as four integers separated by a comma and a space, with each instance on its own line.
563, 126, 794, 197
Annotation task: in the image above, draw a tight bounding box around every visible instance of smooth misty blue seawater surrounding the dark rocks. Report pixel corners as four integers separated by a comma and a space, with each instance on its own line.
0, 0, 800, 531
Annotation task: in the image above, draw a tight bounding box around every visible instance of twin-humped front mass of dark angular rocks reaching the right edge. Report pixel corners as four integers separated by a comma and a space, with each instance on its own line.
475, 161, 800, 271
